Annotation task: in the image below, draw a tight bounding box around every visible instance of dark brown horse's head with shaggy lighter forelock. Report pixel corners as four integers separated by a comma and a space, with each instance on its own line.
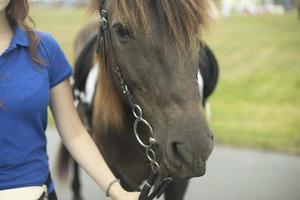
94, 0, 213, 178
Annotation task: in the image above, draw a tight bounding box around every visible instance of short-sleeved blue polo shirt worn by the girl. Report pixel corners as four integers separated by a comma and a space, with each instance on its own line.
0, 27, 72, 192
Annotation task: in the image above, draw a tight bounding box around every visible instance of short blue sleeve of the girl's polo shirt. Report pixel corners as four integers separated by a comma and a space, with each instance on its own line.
49, 38, 72, 88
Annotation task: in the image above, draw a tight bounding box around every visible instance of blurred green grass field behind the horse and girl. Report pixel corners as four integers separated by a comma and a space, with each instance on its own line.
32, 8, 300, 154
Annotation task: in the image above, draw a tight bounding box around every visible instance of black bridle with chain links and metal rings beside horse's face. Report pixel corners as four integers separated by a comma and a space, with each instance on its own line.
97, 6, 173, 200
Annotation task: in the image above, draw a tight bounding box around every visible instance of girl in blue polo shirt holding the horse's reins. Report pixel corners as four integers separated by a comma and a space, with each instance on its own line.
0, 0, 139, 200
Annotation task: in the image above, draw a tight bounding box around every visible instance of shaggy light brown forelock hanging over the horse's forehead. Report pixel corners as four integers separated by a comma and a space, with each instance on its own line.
90, 0, 210, 54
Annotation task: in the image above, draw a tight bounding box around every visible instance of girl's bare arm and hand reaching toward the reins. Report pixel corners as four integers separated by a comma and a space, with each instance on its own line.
50, 80, 139, 200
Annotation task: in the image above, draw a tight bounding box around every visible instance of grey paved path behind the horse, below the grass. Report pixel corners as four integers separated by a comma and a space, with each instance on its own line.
47, 130, 300, 200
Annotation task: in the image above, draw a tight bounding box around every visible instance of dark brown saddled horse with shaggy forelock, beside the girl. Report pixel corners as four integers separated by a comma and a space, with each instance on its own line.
58, 0, 218, 200
